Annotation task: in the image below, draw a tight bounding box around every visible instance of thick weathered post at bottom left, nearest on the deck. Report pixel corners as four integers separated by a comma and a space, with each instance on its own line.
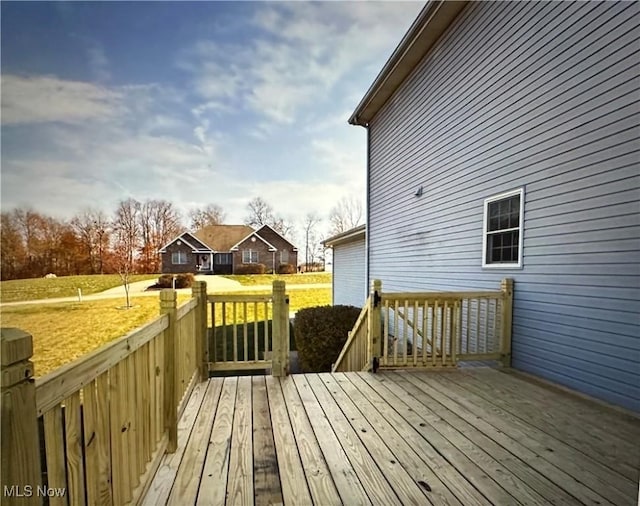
0, 328, 42, 505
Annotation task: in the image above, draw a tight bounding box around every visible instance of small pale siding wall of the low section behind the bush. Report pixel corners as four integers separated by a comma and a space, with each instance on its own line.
333, 236, 367, 307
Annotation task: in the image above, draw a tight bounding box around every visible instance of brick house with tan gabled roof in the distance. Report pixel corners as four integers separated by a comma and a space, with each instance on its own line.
160, 225, 298, 274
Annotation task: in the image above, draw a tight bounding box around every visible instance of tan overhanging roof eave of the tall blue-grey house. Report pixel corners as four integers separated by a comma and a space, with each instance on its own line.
349, 0, 469, 126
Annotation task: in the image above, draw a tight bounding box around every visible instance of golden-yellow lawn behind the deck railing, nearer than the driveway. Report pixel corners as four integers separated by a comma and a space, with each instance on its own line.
0, 288, 331, 376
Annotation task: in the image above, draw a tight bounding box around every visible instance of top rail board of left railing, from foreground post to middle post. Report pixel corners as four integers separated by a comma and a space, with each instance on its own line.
36, 315, 169, 416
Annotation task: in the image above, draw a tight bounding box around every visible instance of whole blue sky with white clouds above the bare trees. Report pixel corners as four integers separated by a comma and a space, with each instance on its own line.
0, 1, 423, 236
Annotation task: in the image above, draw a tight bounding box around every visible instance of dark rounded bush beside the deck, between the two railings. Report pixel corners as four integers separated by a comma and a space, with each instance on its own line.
293, 306, 360, 372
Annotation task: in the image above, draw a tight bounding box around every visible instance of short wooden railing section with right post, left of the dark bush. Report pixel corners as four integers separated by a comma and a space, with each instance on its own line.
207, 281, 290, 376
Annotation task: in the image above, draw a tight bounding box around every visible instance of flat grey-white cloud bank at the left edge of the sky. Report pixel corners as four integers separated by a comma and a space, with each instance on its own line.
2, 74, 122, 125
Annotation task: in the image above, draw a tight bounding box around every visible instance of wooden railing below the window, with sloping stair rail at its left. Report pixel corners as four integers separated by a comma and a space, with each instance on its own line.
333, 279, 513, 371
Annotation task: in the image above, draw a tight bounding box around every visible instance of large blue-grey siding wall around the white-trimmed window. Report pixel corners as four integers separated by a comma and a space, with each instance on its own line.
368, 2, 640, 411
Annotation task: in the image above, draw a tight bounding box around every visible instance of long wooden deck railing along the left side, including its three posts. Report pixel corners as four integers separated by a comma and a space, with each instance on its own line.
1, 283, 208, 505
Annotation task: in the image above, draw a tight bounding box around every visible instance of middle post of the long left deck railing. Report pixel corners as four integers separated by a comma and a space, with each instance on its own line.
160, 288, 180, 453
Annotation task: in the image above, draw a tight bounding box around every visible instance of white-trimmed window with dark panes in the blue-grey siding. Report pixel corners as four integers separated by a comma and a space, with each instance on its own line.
482, 188, 524, 268
